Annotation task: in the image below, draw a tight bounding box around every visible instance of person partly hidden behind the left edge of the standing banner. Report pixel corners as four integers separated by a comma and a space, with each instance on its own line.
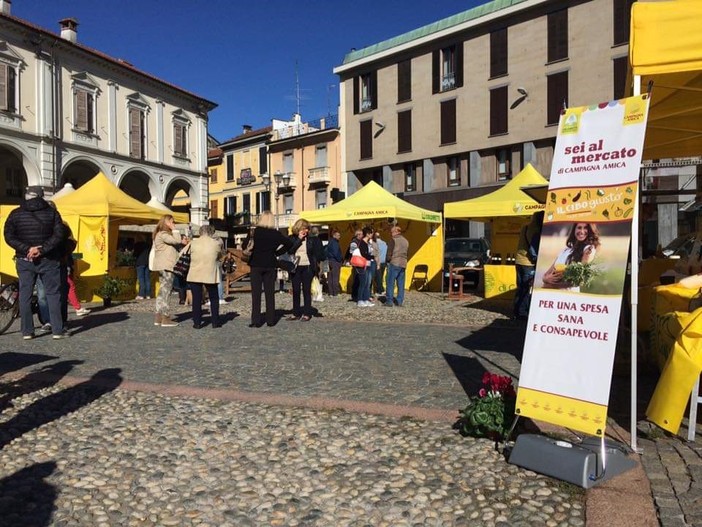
513, 211, 544, 320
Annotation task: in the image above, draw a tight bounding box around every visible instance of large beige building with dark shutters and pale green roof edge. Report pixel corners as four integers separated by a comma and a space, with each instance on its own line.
334, 0, 633, 235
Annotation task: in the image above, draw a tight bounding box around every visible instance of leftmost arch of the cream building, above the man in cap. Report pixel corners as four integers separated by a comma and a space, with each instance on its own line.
0, 138, 43, 204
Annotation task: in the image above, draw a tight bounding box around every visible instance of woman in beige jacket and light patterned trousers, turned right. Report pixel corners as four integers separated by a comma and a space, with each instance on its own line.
152, 214, 188, 327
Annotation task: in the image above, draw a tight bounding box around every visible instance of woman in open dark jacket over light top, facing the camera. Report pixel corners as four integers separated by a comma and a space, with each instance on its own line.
288, 219, 322, 322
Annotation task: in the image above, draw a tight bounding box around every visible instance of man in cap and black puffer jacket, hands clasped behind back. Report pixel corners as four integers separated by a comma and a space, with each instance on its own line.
4, 186, 67, 340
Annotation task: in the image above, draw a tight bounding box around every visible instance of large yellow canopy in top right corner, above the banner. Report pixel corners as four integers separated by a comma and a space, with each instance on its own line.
629, 0, 702, 159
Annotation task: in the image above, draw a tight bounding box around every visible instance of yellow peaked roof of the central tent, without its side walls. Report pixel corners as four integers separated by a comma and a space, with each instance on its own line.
300, 181, 441, 223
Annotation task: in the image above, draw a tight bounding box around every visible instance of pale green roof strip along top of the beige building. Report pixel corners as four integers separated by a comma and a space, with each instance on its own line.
343, 0, 527, 64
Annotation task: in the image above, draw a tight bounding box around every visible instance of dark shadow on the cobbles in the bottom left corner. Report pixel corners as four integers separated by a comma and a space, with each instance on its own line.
0, 461, 58, 527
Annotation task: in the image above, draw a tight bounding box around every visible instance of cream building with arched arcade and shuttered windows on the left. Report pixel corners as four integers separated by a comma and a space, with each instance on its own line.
0, 0, 216, 224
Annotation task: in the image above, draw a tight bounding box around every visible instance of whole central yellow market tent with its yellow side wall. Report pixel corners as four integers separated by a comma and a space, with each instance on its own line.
300, 181, 443, 289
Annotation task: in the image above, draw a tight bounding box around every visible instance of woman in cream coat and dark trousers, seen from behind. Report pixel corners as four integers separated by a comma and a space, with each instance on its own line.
183, 225, 224, 329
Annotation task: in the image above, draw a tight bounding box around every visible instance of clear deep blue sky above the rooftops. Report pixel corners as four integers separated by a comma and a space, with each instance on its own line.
12, 0, 486, 141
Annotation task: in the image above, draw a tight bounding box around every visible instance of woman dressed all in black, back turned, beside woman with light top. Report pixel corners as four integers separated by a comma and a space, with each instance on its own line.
249, 210, 293, 328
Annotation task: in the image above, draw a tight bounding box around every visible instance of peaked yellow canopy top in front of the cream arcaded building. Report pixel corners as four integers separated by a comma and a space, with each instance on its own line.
54, 172, 189, 223
